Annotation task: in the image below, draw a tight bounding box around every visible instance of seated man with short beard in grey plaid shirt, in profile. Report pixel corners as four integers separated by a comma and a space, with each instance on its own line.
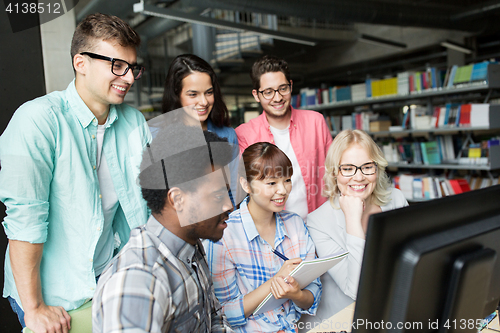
92, 125, 233, 333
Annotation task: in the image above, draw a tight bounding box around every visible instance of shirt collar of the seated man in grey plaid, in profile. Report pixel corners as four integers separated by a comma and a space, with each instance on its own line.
146, 215, 196, 264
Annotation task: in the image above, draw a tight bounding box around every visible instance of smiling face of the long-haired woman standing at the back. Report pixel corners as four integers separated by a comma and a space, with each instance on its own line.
179, 72, 214, 124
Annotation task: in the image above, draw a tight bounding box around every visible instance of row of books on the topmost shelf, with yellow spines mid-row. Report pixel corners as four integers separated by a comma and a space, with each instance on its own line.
292, 61, 491, 108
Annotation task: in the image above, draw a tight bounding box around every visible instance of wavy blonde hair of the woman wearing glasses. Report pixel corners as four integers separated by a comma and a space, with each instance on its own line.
323, 129, 391, 207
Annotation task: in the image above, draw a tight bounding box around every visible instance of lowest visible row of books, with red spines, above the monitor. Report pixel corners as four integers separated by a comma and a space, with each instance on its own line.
393, 174, 499, 200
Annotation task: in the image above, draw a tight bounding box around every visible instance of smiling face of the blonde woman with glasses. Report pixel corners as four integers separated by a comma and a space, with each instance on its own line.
336, 144, 377, 200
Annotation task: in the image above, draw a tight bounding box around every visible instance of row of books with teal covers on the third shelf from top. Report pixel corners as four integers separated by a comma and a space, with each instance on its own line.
382, 135, 500, 165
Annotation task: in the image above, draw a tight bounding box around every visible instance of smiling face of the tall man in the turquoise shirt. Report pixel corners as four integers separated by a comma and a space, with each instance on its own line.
74, 40, 137, 113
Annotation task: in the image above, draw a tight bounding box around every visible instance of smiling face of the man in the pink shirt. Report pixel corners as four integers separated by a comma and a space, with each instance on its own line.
252, 72, 292, 118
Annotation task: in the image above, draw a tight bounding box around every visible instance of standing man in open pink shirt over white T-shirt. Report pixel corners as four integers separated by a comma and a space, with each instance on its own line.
236, 56, 332, 220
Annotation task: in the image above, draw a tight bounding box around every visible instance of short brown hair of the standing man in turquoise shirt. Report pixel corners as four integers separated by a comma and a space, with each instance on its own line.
71, 13, 141, 59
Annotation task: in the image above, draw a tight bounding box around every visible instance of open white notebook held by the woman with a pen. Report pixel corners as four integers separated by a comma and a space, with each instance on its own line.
253, 252, 349, 315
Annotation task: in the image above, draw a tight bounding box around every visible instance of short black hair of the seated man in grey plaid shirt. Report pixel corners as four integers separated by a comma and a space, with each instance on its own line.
139, 125, 232, 214
